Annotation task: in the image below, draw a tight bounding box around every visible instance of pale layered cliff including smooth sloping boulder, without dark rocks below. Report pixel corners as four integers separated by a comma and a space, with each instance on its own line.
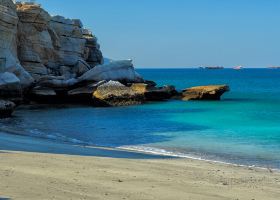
0, 0, 143, 104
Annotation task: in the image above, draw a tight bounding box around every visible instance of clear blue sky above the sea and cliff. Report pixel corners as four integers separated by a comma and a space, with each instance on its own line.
37, 0, 280, 67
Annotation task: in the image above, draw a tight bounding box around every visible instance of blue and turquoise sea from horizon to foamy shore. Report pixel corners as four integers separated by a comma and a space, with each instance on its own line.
0, 69, 280, 169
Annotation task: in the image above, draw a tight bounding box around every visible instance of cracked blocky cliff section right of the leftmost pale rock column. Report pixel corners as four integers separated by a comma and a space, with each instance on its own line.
16, 3, 103, 80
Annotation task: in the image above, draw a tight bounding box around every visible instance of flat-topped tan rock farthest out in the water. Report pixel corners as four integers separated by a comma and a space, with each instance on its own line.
182, 85, 230, 101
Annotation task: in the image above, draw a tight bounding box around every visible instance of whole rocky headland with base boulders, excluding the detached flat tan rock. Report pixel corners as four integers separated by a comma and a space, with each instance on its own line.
0, 0, 229, 117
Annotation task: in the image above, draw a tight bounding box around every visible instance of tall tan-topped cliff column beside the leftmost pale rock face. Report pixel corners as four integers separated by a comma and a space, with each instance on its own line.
17, 3, 58, 80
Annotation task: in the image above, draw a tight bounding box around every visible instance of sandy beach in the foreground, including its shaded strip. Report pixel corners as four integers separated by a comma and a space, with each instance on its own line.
0, 134, 280, 200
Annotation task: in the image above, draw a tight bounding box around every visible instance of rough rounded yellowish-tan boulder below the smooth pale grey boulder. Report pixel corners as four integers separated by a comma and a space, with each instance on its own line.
93, 81, 145, 106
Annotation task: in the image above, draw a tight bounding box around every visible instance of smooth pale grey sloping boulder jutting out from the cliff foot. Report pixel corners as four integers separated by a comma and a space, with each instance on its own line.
78, 60, 143, 83
